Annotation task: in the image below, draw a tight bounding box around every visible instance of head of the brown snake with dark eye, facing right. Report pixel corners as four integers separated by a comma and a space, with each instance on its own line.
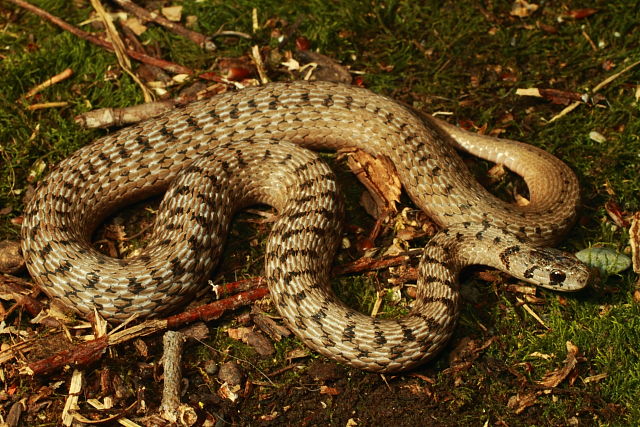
512, 248, 591, 292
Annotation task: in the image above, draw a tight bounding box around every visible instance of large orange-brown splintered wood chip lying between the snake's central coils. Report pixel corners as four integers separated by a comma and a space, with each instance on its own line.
347, 149, 402, 218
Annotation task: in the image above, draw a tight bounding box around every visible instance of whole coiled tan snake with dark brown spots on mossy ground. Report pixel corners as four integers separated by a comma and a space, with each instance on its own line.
21, 81, 589, 372
